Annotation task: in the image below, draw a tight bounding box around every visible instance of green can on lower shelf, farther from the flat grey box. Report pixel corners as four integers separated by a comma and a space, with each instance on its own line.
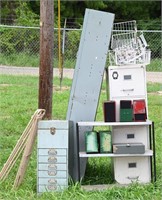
85, 131, 98, 153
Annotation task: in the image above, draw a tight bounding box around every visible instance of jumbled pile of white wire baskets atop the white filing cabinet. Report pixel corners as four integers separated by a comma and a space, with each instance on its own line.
109, 21, 151, 65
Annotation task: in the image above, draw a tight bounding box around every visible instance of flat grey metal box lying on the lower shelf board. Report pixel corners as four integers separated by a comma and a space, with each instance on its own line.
113, 143, 145, 154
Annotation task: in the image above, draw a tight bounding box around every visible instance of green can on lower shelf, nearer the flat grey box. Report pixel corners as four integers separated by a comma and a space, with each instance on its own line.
99, 131, 112, 153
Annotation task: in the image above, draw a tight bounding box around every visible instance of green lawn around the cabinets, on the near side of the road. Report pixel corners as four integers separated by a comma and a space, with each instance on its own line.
0, 75, 162, 200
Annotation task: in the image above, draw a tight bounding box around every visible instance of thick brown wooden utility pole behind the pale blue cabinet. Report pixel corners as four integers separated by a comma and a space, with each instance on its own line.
38, 0, 54, 119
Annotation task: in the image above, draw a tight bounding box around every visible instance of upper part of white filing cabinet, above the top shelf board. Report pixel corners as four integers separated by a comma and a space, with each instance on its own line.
109, 65, 148, 122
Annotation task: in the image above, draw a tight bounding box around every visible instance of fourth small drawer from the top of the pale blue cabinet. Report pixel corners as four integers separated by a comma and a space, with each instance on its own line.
38, 170, 67, 178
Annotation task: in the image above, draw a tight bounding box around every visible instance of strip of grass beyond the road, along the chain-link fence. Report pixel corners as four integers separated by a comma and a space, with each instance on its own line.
0, 53, 162, 72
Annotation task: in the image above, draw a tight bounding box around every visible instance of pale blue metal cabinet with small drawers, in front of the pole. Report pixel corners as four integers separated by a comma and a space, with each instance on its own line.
37, 120, 69, 193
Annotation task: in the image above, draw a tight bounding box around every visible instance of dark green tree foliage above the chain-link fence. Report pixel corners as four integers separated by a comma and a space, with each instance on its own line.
1, 0, 161, 29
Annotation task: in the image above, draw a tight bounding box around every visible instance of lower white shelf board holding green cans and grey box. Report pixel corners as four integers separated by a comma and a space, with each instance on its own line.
79, 150, 153, 158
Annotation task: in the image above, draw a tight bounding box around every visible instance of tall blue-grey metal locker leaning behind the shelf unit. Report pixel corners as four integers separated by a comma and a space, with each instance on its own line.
66, 9, 114, 181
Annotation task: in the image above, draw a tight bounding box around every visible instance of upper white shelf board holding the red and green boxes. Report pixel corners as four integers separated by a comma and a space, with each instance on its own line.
78, 120, 152, 126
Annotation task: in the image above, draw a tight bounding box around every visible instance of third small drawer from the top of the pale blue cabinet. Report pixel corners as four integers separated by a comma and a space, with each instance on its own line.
38, 164, 67, 171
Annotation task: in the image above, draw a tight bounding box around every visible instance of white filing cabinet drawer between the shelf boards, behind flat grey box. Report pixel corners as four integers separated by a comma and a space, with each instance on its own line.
112, 126, 150, 149
